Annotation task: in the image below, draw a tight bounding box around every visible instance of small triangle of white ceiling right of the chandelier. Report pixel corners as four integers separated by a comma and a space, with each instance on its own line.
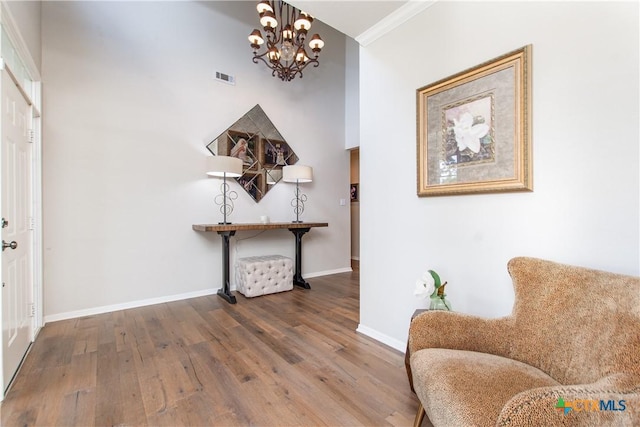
288, 0, 410, 40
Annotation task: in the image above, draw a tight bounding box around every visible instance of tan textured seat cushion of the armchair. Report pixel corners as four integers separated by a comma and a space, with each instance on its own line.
410, 348, 560, 426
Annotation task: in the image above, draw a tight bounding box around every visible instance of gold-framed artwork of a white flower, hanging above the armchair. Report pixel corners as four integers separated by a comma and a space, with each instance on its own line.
417, 45, 533, 197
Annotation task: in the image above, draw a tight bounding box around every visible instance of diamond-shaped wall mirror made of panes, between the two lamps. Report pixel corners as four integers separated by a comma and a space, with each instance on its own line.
207, 105, 298, 202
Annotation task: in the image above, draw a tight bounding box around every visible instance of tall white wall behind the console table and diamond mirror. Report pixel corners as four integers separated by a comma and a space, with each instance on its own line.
42, 2, 350, 320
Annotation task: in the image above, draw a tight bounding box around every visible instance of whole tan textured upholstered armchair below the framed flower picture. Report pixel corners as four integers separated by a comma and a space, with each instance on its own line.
409, 258, 640, 427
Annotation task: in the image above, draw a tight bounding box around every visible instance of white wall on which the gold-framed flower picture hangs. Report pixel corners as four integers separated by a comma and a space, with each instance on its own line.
360, 2, 640, 349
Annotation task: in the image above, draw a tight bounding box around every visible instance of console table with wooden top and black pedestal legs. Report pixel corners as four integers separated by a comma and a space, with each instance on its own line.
192, 222, 329, 304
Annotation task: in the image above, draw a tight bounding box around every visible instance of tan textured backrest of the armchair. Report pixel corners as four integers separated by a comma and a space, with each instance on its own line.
508, 257, 640, 384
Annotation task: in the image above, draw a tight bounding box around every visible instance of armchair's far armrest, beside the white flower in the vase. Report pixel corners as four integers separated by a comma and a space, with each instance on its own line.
408, 310, 513, 357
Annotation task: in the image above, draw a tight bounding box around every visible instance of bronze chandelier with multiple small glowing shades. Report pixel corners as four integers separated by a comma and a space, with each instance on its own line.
249, 0, 324, 82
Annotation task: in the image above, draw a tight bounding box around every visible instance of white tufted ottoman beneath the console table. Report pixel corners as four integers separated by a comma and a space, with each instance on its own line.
236, 255, 293, 298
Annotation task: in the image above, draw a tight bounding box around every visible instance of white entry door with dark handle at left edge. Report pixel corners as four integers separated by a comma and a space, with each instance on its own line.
0, 70, 33, 391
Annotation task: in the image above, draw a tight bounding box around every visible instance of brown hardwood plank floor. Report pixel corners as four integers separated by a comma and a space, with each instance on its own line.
0, 271, 418, 426
